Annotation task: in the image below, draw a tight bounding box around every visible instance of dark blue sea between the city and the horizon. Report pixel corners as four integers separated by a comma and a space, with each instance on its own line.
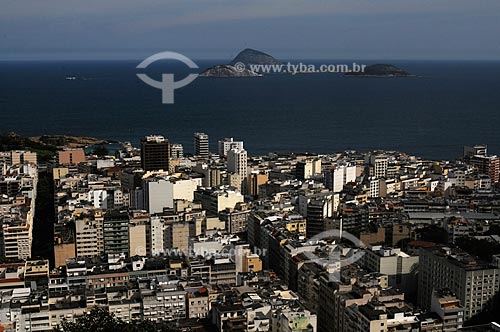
0, 61, 500, 159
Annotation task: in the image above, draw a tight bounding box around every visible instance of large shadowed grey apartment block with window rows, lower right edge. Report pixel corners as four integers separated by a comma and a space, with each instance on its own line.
418, 246, 500, 320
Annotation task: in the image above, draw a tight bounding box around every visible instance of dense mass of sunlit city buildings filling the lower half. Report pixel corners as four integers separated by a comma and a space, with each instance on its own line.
0, 139, 500, 332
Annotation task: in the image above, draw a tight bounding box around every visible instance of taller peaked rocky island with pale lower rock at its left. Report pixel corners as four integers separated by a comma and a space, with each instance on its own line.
200, 48, 281, 78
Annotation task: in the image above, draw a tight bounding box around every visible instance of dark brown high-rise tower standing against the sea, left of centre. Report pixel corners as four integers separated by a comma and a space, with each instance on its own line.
141, 135, 170, 171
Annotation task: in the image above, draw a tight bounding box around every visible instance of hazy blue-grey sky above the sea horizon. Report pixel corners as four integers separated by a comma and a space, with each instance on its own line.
0, 0, 500, 60
